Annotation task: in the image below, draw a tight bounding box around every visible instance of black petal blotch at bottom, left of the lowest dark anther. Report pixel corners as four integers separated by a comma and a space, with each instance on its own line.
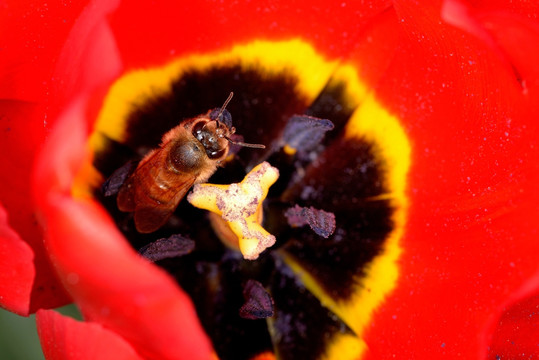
173, 253, 273, 360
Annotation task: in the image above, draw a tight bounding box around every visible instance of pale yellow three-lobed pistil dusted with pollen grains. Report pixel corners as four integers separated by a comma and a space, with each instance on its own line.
187, 162, 279, 260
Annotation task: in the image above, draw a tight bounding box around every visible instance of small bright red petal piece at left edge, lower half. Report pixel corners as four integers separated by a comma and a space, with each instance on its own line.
0, 204, 35, 315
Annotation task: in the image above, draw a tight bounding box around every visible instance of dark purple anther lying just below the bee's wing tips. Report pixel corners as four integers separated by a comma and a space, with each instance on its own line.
139, 235, 195, 261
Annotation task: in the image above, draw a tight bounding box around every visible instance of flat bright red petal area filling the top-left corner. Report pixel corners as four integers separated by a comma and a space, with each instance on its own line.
0, 1, 84, 102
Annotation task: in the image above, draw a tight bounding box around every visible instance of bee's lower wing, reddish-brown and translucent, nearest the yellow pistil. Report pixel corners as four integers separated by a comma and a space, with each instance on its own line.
135, 175, 195, 233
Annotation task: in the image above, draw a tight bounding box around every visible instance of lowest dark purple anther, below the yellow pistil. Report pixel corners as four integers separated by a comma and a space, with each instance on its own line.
240, 280, 273, 320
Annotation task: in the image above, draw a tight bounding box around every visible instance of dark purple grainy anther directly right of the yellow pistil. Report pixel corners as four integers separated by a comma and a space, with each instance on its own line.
284, 205, 335, 238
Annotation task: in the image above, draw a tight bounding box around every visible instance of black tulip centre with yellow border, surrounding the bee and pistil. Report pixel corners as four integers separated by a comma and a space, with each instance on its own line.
73, 40, 411, 359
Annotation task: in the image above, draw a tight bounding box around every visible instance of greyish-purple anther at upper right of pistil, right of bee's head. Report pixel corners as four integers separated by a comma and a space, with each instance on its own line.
283, 115, 334, 152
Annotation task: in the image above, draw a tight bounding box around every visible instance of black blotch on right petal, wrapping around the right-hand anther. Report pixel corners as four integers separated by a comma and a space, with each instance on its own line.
281, 138, 394, 300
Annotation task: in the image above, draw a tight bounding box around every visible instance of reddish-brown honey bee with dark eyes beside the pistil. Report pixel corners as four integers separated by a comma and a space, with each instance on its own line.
116, 93, 265, 233
